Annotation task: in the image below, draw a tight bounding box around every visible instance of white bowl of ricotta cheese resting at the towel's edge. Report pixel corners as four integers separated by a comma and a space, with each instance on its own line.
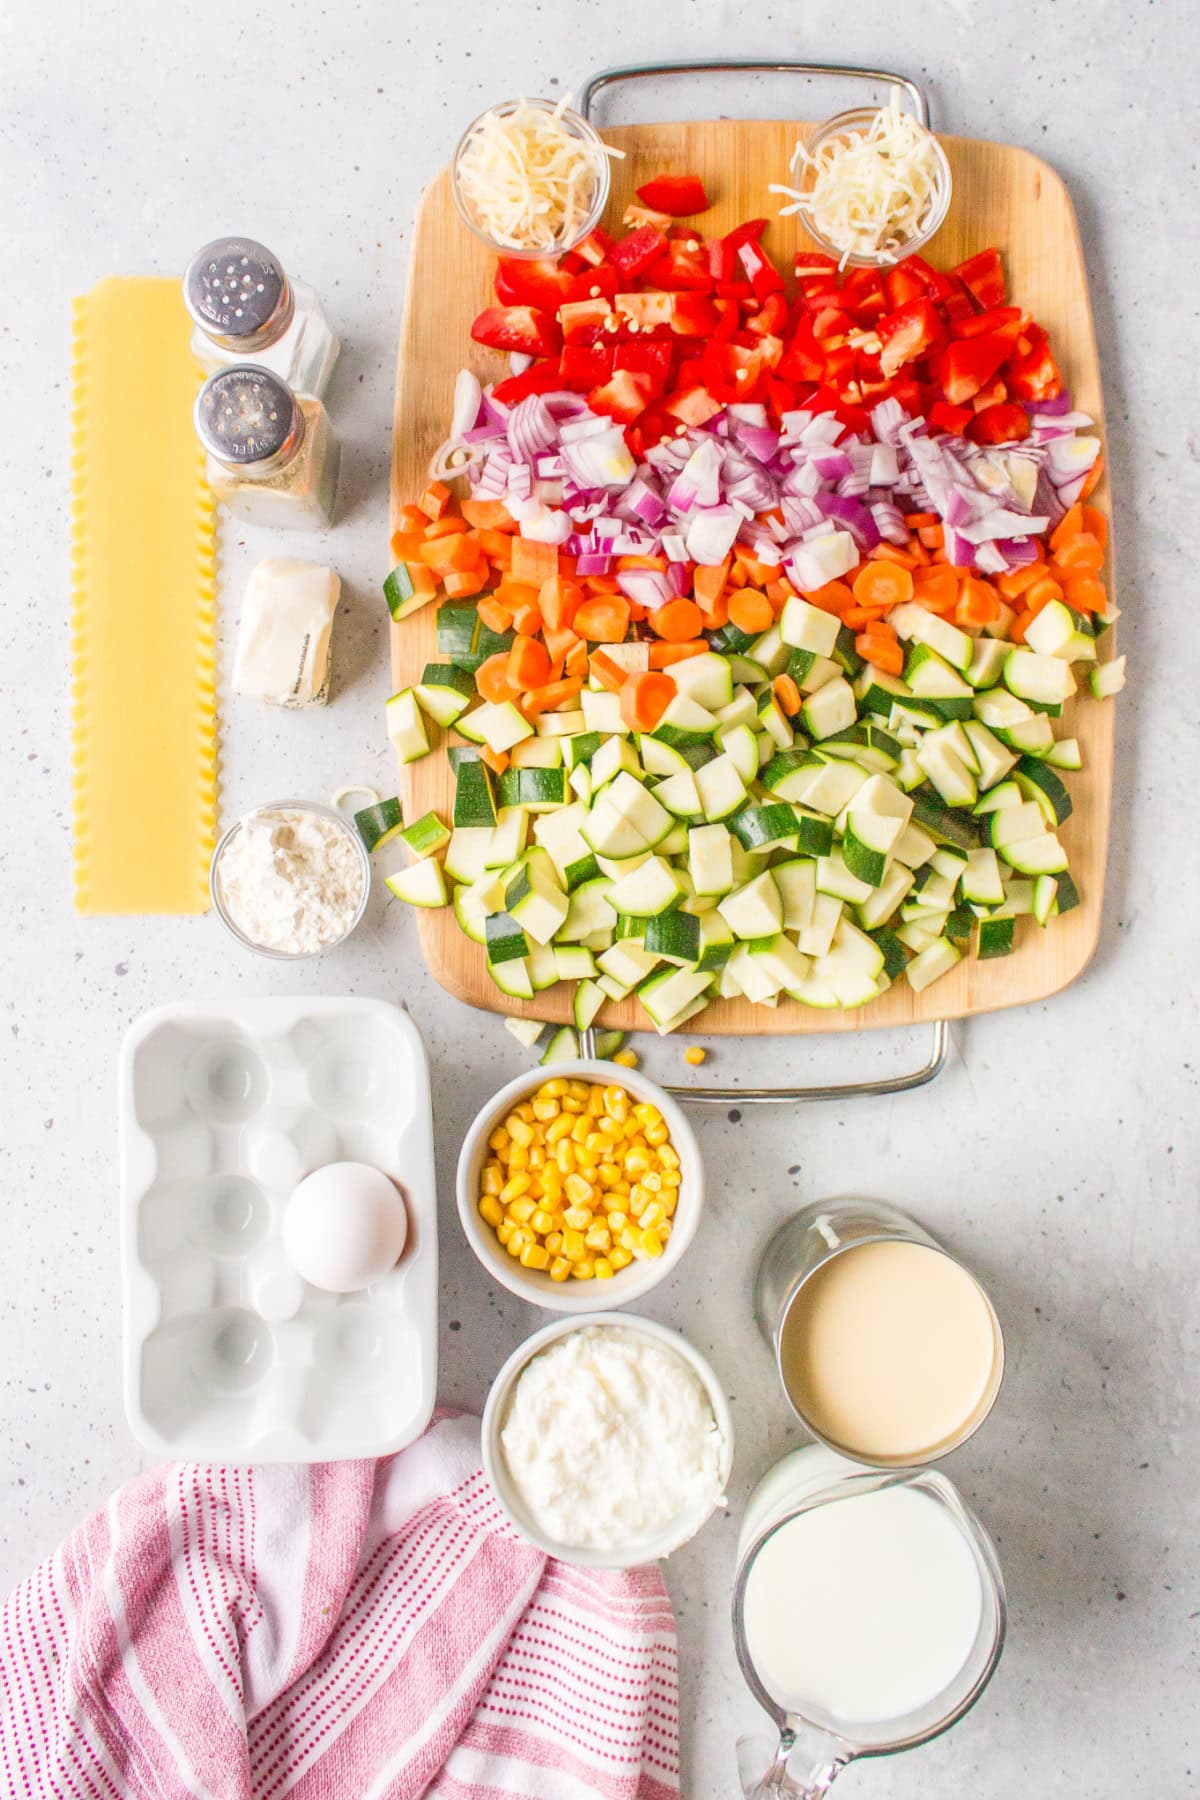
482, 1312, 734, 1570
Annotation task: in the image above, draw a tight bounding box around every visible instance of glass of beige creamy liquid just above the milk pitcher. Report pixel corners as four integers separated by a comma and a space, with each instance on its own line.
756, 1199, 1004, 1469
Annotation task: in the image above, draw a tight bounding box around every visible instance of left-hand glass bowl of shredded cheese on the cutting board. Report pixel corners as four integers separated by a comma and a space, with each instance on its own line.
452, 97, 622, 256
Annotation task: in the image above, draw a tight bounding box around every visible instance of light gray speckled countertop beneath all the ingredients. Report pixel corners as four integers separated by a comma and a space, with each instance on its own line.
0, 0, 1200, 1800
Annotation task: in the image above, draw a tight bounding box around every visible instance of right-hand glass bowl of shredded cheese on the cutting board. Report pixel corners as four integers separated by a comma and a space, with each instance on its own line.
770, 99, 952, 268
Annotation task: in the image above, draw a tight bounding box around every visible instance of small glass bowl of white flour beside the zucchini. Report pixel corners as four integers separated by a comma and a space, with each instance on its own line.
209, 799, 371, 963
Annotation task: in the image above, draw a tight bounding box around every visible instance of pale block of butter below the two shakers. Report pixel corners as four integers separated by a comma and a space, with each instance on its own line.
234, 556, 342, 706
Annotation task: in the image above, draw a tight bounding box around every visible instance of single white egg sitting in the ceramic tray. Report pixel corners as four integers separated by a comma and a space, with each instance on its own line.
282, 1163, 408, 1294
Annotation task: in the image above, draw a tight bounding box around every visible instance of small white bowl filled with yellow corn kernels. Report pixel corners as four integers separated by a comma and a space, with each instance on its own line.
459, 1062, 703, 1312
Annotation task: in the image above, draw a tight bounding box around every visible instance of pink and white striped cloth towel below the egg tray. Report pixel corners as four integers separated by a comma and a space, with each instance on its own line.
0, 1415, 680, 1800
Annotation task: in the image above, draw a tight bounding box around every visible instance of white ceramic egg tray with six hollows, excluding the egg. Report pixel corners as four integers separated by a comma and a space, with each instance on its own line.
121, 999, 437, 1463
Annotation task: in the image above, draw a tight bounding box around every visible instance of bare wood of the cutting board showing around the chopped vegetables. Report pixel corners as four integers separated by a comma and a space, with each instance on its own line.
392, 119, 1115, 1037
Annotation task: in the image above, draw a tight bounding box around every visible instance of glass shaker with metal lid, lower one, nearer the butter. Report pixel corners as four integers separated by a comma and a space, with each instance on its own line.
196, 364, 342, 531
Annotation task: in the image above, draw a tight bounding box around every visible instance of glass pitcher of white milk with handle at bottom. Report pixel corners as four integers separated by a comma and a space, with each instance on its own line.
734, 1445, 1006, 1800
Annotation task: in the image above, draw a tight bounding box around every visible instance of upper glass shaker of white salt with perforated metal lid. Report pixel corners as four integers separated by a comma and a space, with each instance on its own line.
184, 238, 342, 400
